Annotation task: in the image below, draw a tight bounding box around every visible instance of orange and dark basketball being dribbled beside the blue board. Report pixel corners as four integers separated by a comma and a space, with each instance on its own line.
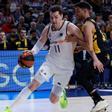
18, 51, 34, 68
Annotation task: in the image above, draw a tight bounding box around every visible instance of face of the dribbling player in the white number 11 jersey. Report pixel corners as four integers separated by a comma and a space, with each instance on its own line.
50, 11, 63, 28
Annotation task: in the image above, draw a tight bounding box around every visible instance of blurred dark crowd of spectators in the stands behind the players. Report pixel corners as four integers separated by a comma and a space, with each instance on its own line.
0, 0, 112, 87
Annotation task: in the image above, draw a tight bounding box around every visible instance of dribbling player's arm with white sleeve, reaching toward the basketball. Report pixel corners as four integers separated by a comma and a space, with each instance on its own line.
31, 26, 48, 55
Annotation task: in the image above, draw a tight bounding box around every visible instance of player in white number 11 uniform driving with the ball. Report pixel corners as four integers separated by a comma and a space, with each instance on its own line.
5, 5, 102, 112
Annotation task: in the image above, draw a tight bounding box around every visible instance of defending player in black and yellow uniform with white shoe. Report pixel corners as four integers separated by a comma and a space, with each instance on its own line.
66, 2, 108, 112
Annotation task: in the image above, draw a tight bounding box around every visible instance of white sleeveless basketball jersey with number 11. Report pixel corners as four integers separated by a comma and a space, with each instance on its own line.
46, 21, 74, 70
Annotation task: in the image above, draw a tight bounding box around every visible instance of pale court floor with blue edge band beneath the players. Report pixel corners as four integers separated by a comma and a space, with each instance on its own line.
0, 91, 112, 112
